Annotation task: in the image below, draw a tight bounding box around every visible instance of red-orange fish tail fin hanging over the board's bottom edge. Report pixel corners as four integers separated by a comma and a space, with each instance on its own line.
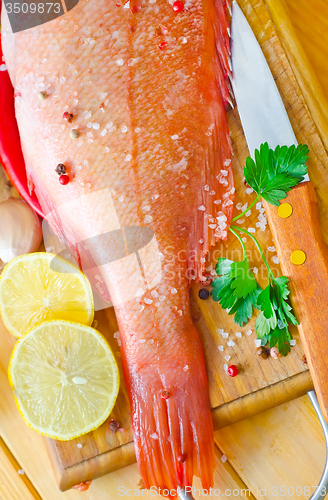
123, 330, 215, 490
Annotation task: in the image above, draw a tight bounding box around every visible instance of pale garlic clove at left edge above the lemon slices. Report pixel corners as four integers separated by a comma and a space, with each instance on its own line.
0, 198, 42, 263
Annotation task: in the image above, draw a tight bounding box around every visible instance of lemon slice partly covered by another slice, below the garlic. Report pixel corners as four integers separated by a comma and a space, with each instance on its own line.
0, 252, 94, 337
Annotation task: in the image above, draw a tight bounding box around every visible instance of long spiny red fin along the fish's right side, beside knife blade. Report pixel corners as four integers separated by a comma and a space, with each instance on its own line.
188, 0, 235, 281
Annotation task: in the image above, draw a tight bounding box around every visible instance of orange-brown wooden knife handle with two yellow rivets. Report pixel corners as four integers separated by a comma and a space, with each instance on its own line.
264, 182, 328, 422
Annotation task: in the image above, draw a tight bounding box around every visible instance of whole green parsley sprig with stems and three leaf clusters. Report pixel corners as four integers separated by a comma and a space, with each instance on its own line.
212, 143, 309, 356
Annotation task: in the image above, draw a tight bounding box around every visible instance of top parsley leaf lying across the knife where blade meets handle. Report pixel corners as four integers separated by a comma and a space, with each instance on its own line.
244, 142, 309, 206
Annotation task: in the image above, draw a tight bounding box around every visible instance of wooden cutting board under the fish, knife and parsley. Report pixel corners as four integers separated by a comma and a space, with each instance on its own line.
0, 0, 328, 490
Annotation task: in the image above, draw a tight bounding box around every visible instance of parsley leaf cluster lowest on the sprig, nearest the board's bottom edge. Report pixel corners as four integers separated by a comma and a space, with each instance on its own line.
255, 276, 298, 356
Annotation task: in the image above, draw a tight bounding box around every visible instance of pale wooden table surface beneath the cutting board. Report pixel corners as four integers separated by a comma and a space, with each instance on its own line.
0, 0, 328, 500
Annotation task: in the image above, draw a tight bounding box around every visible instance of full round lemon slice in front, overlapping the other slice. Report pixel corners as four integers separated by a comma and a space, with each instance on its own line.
8, 321, 120, 441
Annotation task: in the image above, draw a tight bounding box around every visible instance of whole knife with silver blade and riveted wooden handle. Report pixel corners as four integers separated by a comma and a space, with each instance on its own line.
231, 1, 328, 422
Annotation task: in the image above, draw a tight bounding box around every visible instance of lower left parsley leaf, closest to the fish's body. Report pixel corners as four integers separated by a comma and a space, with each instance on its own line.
211, 258, 261, 326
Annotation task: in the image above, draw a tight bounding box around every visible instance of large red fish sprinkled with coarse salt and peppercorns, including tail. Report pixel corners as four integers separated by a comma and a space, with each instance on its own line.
2, 0, 234, 488
